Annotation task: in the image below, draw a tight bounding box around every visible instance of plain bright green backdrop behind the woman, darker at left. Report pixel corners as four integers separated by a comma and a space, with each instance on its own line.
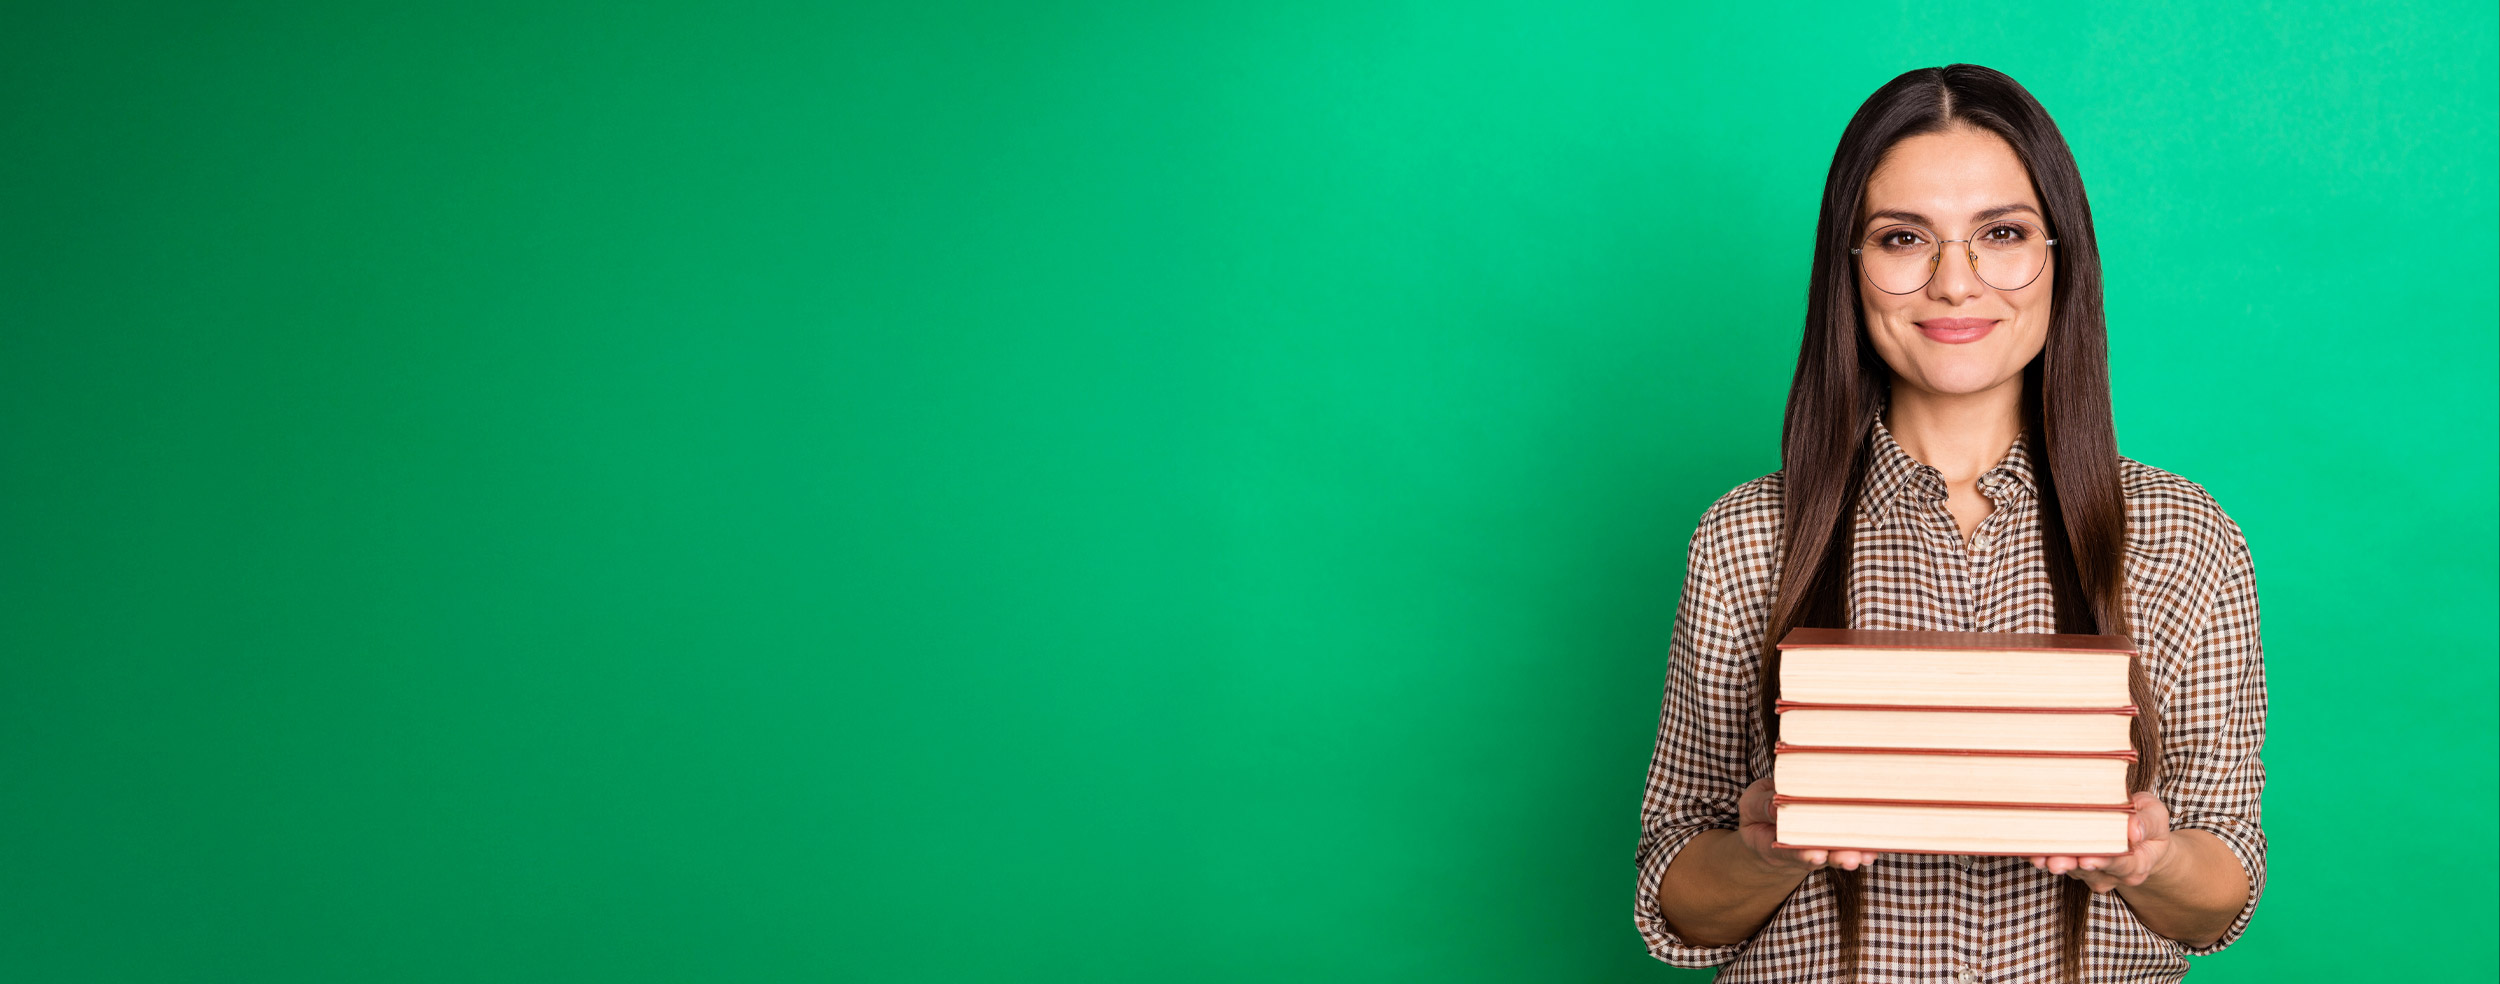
0, 2, 2500, 982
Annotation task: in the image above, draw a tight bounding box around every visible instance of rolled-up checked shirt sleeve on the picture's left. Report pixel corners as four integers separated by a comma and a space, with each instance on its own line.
1633, 519, 1760, 967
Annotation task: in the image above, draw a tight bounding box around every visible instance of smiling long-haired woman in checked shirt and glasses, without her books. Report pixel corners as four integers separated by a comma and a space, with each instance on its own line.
1635, 65, 2265, 984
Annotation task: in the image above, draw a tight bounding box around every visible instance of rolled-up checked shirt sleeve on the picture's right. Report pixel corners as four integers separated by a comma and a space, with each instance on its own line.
2163, 527, 2265, 957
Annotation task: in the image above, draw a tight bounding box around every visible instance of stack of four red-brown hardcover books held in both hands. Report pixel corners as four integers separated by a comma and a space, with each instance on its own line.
1770, 629, 2135, 857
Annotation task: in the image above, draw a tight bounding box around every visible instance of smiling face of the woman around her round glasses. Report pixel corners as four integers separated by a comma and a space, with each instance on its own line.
1858, 127, 2058, 397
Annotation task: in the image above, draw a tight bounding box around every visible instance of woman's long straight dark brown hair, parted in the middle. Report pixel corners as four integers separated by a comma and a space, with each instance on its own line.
1758, 65, 2163, 982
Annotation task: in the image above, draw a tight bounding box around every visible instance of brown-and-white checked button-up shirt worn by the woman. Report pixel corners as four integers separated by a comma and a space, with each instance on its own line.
1633, 420, 2265, 984
